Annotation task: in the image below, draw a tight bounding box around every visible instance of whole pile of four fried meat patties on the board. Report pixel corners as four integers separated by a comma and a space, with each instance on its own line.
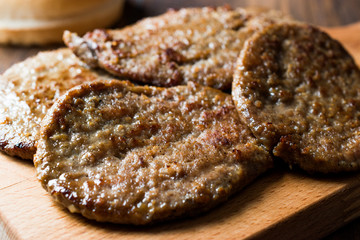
0, 7, 360, 224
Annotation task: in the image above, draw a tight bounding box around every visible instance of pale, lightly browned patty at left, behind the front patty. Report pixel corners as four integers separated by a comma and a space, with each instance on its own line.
0, 49, 112, 159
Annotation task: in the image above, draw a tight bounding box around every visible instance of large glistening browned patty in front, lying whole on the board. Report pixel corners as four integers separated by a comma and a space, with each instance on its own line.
34, 81, 272, 224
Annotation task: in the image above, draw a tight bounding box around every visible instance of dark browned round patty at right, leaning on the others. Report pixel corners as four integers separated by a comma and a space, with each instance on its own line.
232, 24, 360, 173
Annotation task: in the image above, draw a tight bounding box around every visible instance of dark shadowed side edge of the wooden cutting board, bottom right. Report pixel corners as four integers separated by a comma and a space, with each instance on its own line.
245, 175, 360, 240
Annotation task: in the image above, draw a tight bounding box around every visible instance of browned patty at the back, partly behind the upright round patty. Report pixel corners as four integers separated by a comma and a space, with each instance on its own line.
64, 7, 289, 90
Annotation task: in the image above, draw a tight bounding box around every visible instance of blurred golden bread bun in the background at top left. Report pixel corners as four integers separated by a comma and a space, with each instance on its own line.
0, 0, 124, 45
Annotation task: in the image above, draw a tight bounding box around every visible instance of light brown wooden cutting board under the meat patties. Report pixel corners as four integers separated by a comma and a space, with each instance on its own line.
0, 23, 360, 240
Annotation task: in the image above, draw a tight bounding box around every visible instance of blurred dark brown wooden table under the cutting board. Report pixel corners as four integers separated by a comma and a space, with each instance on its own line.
0, 0, 360, 240
